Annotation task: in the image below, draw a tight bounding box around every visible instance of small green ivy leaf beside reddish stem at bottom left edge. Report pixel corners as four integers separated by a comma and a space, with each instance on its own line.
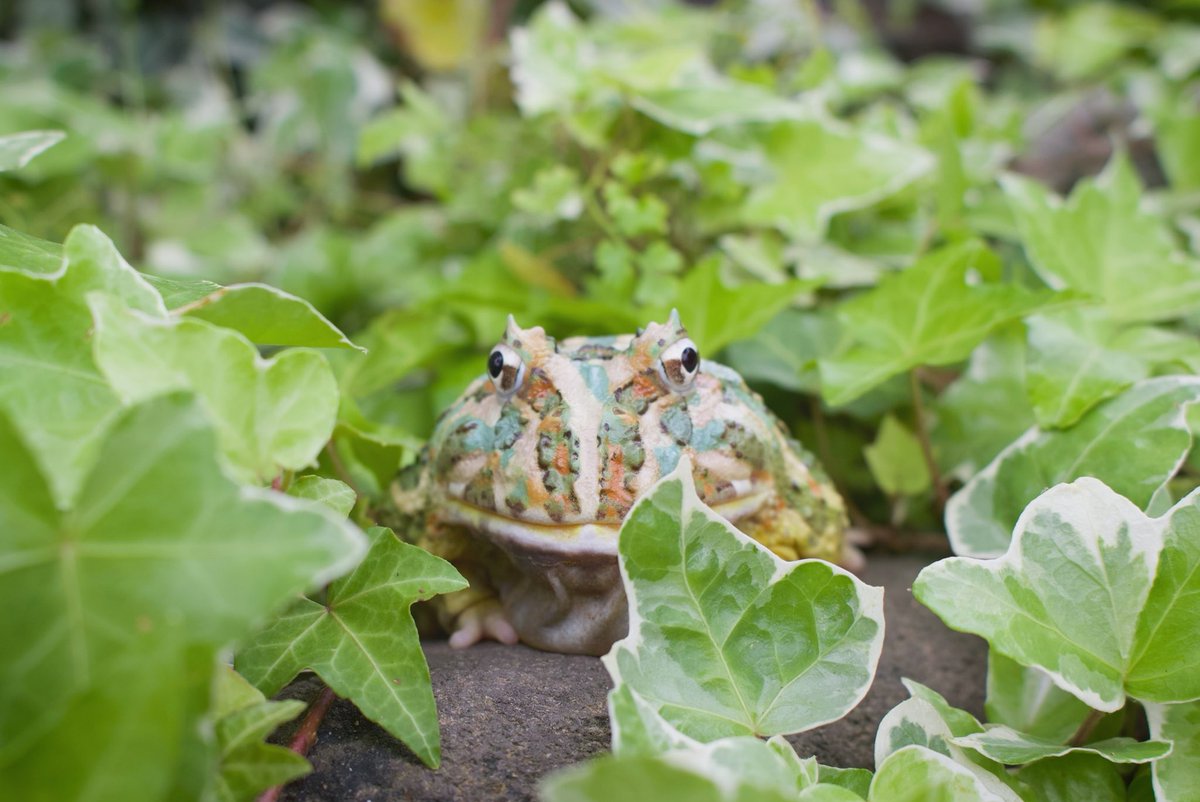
214, 666, 312, 802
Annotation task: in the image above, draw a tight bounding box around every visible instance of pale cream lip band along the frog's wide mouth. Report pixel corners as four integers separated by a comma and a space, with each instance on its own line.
440, 489, 773, 556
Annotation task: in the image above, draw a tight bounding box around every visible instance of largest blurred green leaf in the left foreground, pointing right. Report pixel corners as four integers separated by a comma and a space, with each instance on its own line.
0, 395, 362, 801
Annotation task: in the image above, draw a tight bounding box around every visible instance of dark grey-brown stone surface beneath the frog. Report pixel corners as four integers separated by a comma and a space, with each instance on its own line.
280, 556, 986, 802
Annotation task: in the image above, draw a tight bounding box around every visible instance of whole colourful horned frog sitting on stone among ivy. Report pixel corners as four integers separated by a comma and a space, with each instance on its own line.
392, 312, 846, 654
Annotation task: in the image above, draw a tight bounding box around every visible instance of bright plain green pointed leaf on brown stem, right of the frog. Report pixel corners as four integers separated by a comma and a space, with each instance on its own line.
821, 243, 1052, 405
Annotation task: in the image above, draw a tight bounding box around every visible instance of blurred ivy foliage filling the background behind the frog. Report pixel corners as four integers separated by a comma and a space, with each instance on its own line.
0, 0, 1200, 526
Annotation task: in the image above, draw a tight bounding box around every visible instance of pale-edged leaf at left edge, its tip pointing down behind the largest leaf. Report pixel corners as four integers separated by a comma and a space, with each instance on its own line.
0, 226, 166, 508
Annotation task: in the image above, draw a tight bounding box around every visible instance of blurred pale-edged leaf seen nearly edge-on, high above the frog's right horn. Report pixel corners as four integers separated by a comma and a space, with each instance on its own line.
630, 84, 806, 137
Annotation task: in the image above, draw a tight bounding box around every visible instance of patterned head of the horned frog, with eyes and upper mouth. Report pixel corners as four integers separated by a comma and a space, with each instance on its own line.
427, 312, 806, 552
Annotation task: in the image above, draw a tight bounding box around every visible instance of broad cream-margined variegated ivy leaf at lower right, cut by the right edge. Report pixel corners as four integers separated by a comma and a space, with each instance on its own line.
913, 475, 1200, 712
